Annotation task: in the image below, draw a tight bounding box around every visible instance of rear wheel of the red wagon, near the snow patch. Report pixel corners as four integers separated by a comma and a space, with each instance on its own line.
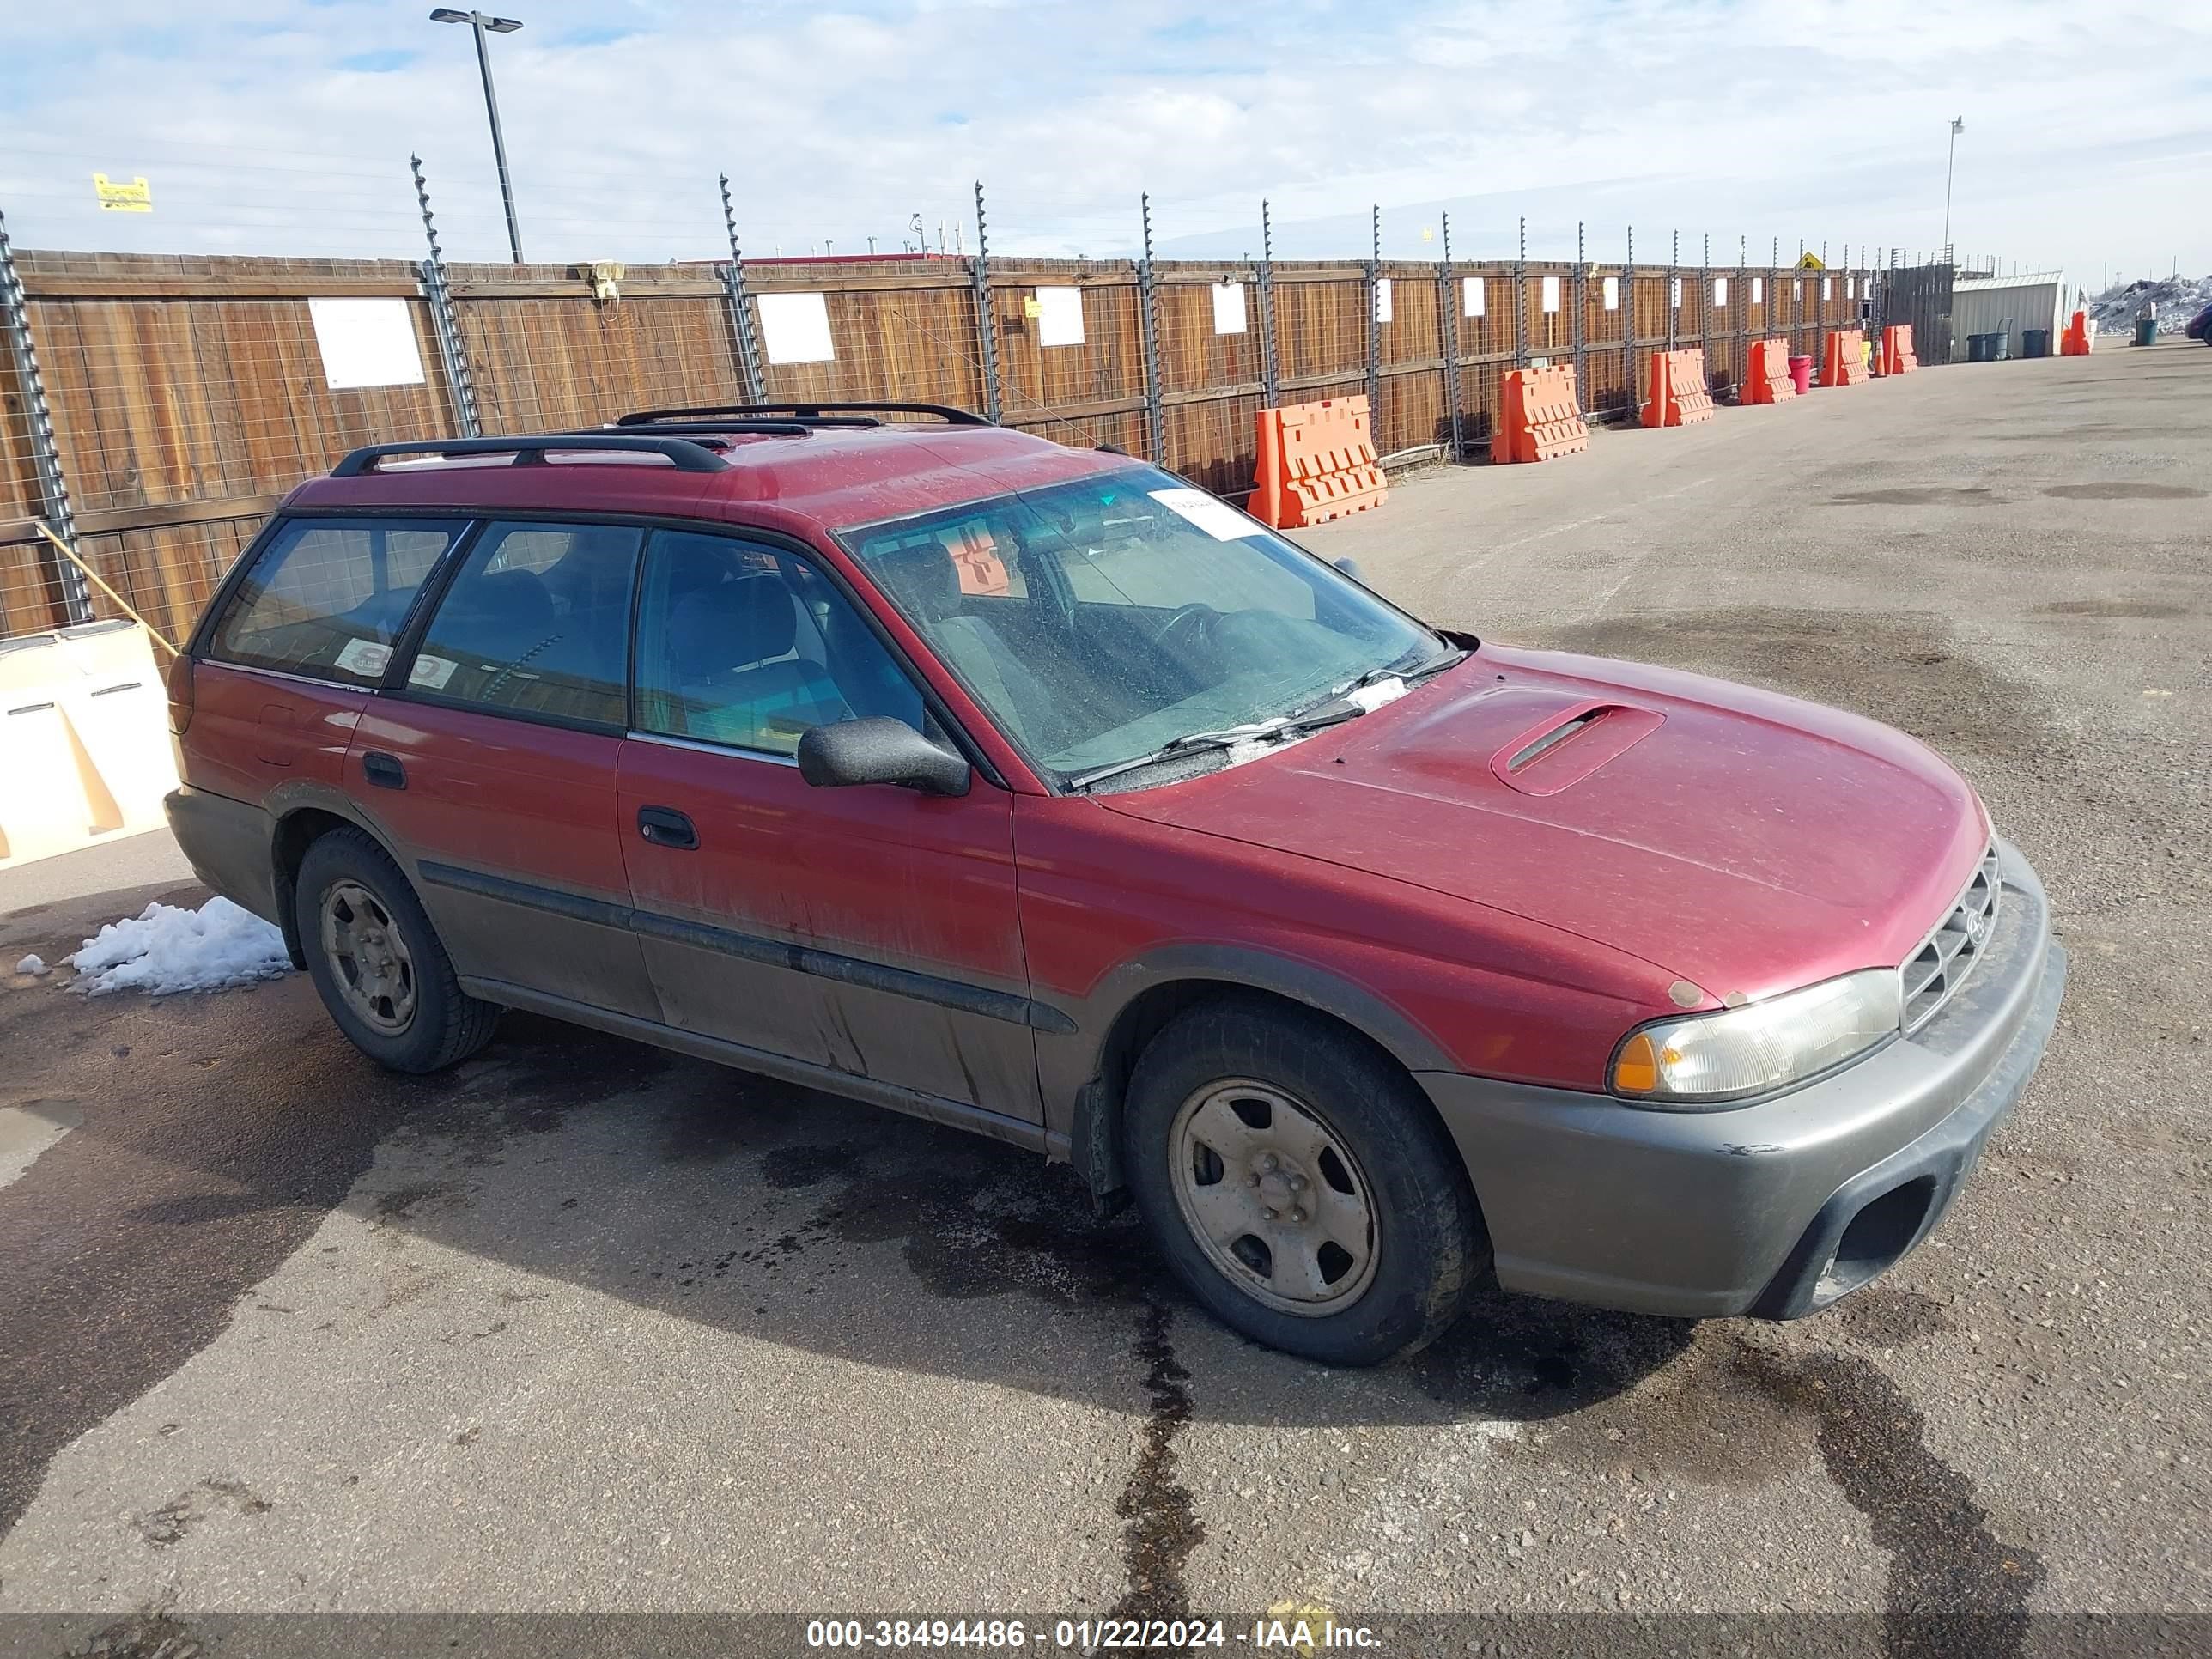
292, 830, 500, 1075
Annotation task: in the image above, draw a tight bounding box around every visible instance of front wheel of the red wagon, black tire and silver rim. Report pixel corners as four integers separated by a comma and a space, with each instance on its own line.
1121, 998, 1491, 1364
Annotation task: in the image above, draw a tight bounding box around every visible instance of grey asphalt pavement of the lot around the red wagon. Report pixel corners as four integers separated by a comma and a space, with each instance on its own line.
0, 345, 2212, 1655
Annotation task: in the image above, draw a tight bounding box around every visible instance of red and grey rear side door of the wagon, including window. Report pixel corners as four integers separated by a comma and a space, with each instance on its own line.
358, 520, 659, 1020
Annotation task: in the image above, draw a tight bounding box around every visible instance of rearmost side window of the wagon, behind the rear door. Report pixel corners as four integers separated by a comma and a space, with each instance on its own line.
210, 518, 467, 686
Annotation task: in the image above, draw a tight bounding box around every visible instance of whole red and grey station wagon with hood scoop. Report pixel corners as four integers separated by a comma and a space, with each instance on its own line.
170, 404, 2066, 1363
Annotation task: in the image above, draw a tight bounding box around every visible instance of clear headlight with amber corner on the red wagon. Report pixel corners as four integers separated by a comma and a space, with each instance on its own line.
1613, 969, 1902, 1106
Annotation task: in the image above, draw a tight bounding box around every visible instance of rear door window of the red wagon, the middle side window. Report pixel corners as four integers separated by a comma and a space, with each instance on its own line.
407, 525, 644, 728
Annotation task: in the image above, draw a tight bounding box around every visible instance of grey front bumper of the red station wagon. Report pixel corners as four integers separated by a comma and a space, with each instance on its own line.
1420, 842, 2066, 1318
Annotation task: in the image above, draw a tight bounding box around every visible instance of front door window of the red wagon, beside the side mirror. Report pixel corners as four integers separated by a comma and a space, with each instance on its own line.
637, 531, 924, 757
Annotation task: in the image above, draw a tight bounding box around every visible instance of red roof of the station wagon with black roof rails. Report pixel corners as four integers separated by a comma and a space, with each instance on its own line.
289, 420, 1133, 531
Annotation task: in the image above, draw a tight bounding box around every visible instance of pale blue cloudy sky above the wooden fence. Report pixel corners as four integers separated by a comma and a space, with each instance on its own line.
0, 0, 2212, 285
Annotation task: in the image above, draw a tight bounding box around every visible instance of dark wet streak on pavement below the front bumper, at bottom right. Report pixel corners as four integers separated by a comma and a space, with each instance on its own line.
1735, 1338, 2044, 1659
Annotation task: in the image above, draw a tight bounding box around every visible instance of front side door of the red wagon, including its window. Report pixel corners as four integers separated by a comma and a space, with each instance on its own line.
617, 531, 1042, 1121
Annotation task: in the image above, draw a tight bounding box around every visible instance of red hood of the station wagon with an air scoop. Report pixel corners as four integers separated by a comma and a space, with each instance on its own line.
1099, 646, 1989, 1000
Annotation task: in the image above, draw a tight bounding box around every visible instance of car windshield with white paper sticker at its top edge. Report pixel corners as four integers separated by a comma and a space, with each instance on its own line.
841, 467, 1449, 779
